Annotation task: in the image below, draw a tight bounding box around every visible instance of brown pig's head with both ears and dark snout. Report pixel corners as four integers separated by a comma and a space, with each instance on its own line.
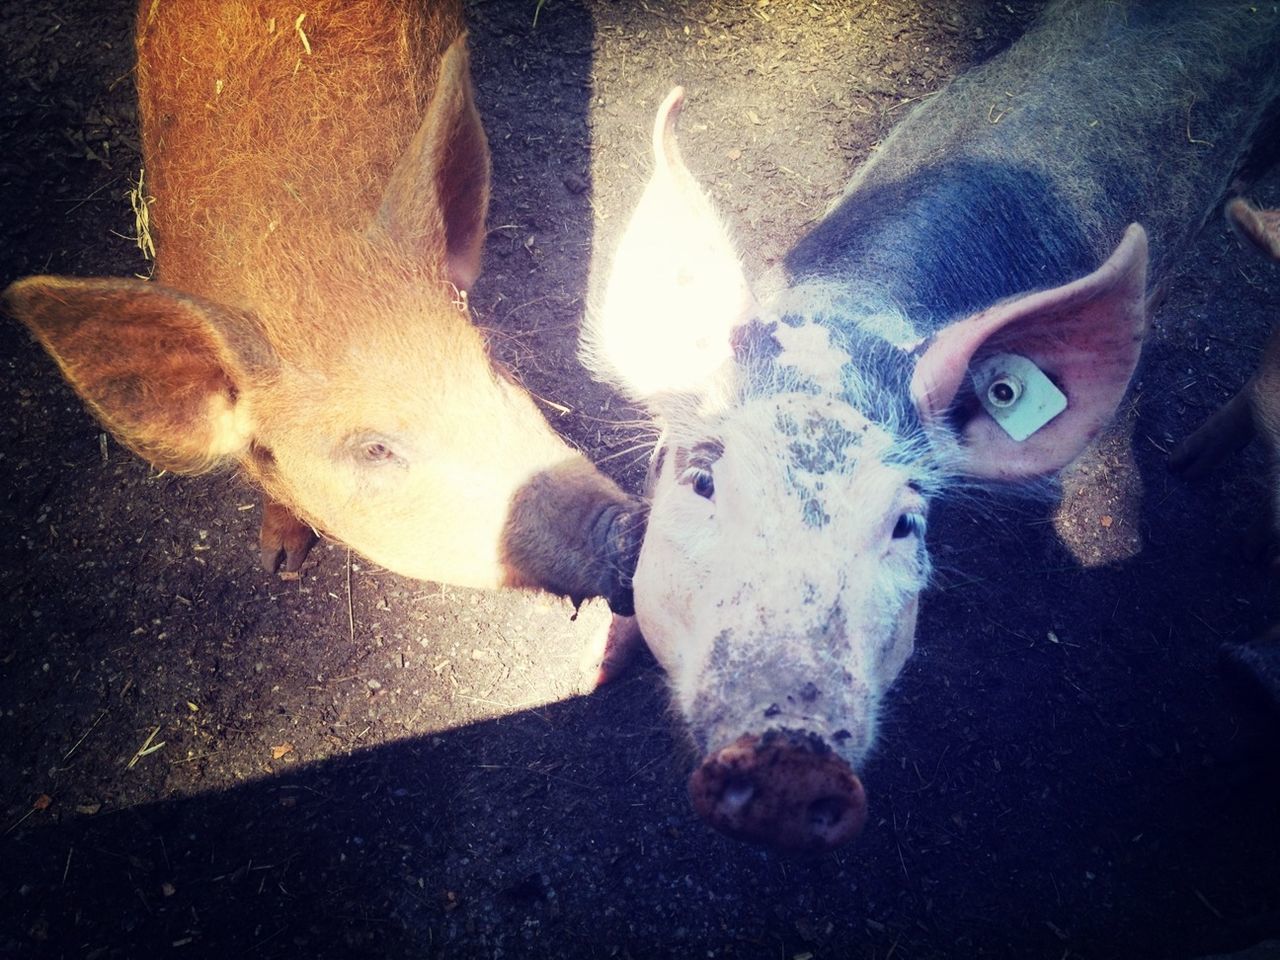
5, 40, 644, 612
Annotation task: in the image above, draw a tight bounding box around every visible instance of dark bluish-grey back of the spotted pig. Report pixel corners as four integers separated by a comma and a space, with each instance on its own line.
787, 0, 1280, 334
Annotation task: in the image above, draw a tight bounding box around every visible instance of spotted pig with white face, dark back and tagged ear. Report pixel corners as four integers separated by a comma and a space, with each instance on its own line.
584, 0, 1280, 851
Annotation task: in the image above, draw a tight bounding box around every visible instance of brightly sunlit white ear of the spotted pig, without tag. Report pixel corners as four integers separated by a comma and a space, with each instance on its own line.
582, 87, 755, 406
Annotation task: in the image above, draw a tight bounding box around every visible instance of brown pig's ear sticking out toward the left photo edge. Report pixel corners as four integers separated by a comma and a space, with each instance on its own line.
4, 276, 275, 474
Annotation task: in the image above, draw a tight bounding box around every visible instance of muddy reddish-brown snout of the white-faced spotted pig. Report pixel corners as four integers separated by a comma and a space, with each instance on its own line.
689, 730, 867, 854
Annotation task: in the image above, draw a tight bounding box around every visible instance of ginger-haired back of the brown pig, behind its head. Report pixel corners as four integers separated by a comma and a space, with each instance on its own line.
136, 0, 463, 303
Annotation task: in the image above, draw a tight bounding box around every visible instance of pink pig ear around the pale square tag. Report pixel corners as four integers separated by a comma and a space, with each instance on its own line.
911, 224, 1147, 480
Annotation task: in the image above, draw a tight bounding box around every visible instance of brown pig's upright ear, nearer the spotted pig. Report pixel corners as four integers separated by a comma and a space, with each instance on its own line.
374, 35, 489, 289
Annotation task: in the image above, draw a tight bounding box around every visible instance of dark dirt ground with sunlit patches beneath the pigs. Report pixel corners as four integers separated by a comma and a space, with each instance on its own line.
0, 0, 1280, 960
